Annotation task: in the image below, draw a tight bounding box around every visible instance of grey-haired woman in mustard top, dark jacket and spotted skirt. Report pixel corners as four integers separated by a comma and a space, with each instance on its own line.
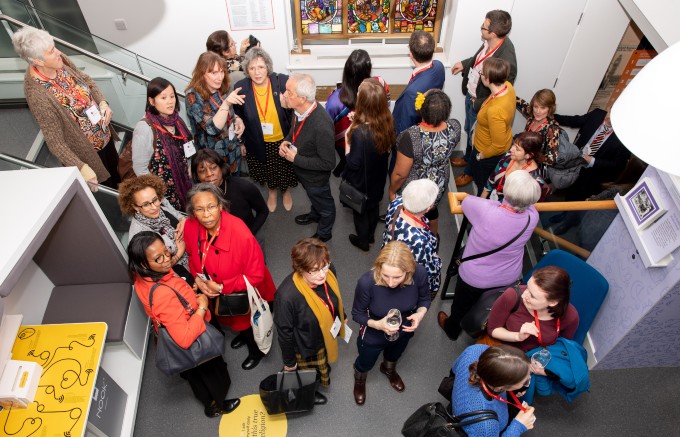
234, 47, 298, 212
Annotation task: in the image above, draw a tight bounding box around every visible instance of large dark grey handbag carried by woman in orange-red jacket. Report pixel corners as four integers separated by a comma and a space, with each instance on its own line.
149, 283, 224, 376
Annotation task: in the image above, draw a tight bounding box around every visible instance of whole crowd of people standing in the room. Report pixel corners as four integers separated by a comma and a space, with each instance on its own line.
13, 10, 630, 430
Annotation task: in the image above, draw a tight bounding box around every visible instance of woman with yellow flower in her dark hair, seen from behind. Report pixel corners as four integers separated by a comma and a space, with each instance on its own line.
390, 89, 460, 235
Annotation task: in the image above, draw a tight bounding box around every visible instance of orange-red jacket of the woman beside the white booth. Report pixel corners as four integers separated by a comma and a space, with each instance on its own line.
135, 271, 210, 349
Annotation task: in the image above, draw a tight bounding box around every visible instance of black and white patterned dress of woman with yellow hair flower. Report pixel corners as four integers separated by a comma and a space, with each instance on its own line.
397, 118, 460, 206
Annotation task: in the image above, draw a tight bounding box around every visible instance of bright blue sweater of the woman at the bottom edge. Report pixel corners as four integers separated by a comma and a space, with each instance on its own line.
451, 344, 527, 437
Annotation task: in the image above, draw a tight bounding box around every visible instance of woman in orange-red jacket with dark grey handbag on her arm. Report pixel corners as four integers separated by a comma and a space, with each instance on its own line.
128, 231, 241, 417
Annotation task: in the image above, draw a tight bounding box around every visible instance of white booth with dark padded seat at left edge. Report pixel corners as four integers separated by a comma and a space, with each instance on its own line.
0, 167, 149, 436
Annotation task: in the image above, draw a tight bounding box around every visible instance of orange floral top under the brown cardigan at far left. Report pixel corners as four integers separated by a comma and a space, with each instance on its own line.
34, 68, 111, 150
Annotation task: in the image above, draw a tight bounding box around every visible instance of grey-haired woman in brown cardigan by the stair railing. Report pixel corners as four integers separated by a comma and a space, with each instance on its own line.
12, 26, 120, 189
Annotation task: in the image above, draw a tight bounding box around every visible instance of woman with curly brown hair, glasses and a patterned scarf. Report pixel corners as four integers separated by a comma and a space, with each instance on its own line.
118, 174, 193, 284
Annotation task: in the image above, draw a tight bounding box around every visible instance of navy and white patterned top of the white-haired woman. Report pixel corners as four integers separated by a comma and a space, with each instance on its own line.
383, 196, 442, 296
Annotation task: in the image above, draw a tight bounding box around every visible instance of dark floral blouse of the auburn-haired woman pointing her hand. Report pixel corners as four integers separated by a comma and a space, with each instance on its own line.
186, 88, 241, 175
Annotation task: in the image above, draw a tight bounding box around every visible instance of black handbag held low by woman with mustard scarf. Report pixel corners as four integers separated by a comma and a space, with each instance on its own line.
260, 370, 319, 414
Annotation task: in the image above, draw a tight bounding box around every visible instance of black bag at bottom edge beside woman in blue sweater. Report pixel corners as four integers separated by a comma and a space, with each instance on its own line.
401, 402, 498, 437
